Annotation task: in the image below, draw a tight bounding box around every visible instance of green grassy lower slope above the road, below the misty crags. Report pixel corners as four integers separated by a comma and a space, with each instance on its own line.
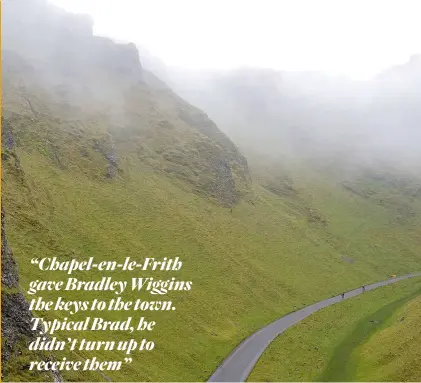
3, 140, 420, 380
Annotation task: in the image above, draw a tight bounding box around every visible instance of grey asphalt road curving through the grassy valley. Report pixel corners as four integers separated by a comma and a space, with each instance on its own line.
208, 273, 421, 382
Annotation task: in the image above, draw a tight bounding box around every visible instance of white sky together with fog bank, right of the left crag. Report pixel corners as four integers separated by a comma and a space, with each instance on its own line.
44, 0, 421, 176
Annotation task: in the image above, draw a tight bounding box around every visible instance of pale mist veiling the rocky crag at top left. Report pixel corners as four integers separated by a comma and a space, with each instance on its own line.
2, 0, 149, 134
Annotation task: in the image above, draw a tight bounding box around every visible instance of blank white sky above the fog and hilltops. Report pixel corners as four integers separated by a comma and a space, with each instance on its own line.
50, 0, 421, 78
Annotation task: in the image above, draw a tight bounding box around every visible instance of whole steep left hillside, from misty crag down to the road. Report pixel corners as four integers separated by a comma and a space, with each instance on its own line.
2, 0, 421, 381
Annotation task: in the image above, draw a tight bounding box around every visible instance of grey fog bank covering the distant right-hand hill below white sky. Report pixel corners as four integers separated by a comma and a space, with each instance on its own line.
140, 48, 421, 174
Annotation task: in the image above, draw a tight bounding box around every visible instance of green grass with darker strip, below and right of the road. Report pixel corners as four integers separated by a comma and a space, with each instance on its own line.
248, 278, 421, 381
